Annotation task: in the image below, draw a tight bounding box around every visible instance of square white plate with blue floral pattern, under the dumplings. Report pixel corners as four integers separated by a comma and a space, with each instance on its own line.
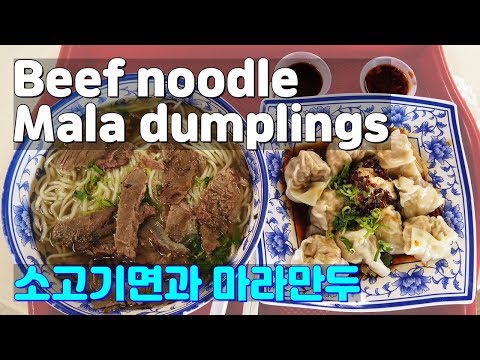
258, 94, 476, 311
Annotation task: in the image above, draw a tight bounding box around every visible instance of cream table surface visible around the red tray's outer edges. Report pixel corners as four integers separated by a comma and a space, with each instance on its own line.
0, 45, 480, 314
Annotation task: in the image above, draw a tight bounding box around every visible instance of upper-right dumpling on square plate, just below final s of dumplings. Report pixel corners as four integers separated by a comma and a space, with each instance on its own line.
376, 129, 421, 179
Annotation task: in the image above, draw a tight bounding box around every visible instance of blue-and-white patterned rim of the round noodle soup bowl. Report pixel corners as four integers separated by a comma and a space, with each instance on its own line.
2, 75, 268, 314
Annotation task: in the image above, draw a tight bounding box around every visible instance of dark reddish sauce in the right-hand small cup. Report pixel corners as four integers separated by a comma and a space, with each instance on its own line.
365, 65, 409, 95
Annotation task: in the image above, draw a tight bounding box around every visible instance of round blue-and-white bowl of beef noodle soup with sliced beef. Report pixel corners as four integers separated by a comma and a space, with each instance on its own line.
3, 78, 267, 314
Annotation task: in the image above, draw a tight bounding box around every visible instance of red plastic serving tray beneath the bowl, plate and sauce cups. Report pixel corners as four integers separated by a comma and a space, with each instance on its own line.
29, 45, 480, 314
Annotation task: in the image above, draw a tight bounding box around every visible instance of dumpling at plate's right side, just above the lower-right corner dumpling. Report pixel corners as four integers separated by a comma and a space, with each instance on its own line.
393, 176, 445, 218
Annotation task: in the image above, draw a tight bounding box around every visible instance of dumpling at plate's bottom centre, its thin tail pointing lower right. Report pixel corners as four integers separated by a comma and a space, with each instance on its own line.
335, 229, 390, 277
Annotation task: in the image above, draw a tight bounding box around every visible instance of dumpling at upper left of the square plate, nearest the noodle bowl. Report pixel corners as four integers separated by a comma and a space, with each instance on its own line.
285, 150, 331, 206
